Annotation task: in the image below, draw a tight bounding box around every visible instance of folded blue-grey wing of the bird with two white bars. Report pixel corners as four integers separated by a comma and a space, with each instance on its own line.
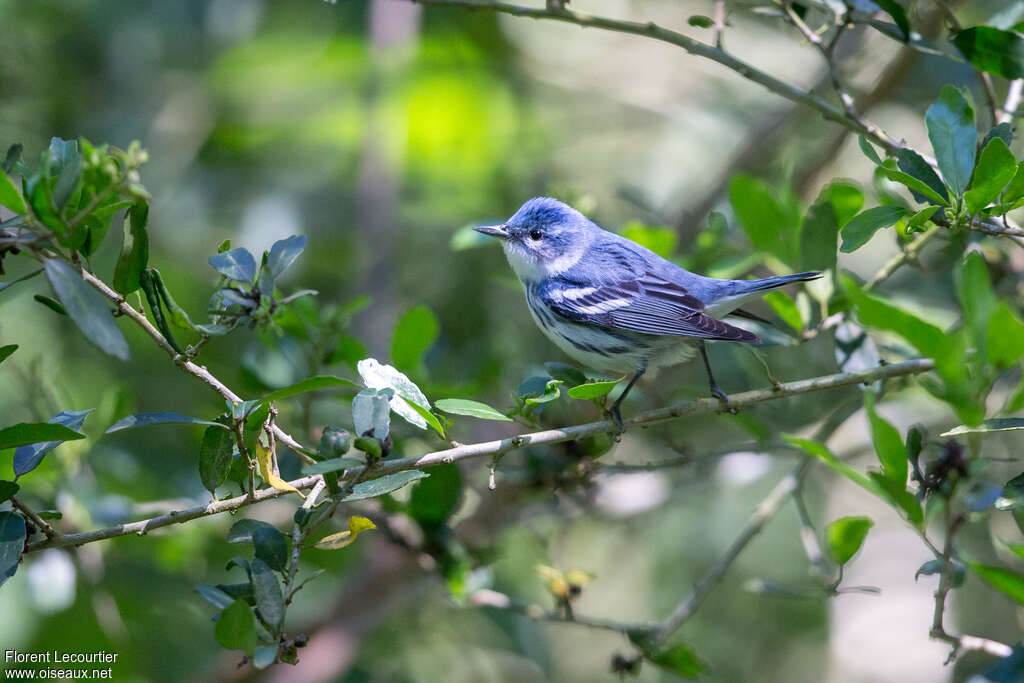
540, 268, 760, 343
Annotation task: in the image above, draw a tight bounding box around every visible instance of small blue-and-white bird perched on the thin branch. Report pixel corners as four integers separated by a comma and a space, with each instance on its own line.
475, 197, 820, 428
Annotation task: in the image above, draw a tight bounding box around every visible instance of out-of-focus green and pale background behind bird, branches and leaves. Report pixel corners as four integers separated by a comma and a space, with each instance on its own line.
0, 0, 1022, 682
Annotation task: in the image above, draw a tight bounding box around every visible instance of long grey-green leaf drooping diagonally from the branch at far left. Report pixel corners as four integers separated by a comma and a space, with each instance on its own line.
43, 258, 129, 360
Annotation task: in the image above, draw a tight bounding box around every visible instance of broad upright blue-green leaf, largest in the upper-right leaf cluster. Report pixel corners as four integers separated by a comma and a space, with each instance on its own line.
925, 85, 978, 197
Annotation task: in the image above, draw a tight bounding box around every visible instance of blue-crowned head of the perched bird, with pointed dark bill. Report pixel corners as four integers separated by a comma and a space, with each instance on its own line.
475, 197, 598, 282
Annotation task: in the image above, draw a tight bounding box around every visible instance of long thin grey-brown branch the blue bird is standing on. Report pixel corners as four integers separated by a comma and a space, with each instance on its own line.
26, 358, 935, 552
